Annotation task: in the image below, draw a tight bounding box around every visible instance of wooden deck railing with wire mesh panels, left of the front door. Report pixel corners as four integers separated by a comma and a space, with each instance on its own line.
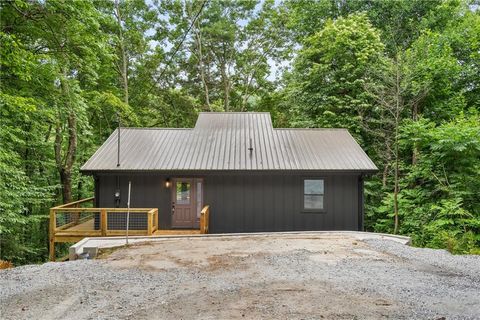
49, 198, 158, 260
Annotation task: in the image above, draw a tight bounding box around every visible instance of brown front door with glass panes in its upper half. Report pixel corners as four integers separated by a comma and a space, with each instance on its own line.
172, 178, 197, 228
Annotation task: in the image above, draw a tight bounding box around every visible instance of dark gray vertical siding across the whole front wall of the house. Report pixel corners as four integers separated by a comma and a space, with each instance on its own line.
96, 172, 362, 233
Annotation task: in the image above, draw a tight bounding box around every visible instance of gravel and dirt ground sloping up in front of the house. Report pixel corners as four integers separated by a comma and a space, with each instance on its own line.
0, 234, 480, 319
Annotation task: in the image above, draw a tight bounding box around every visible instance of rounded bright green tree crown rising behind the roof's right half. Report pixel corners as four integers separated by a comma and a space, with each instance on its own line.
287, 14, 384, 144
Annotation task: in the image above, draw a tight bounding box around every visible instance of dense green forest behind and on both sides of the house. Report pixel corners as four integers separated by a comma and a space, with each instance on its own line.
0, 0, 480, 265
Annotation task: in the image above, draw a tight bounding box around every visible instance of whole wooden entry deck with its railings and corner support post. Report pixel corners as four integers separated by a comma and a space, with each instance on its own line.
49, 198, 210, 261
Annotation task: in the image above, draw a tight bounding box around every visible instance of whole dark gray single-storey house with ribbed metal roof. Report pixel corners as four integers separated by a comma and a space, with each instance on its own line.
81, 112, 377, 233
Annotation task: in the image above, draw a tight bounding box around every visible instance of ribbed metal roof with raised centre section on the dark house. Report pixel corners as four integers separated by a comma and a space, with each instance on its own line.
81, 112, 378, 172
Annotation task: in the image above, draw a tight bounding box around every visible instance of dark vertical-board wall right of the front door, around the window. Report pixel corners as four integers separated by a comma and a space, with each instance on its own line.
204, 174, 359, 233
